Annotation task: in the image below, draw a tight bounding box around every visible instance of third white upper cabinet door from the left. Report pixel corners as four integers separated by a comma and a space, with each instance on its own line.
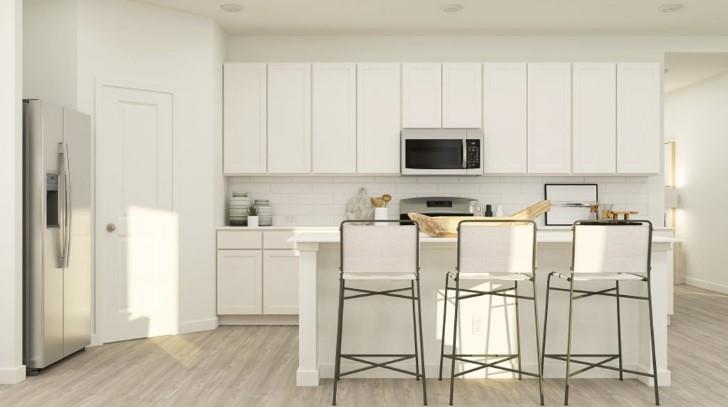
313, 64, 356, 173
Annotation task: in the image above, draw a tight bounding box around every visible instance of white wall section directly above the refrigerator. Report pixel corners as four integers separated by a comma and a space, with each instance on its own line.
23, 0, 78, 109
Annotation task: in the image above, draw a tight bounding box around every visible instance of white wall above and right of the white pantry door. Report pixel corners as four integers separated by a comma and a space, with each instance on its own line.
77, 0, 224, 332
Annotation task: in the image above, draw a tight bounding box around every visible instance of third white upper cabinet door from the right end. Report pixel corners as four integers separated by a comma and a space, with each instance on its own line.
528, 63, 571, 174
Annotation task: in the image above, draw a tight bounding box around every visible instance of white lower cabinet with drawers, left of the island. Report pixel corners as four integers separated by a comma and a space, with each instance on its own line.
217, 230, 298, 316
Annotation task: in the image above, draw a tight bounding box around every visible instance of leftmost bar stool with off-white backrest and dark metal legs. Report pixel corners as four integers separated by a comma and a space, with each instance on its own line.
332, 220, 427, 405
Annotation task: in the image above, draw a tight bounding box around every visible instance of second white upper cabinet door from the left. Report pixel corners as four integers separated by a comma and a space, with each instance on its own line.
268, 64, 311, 173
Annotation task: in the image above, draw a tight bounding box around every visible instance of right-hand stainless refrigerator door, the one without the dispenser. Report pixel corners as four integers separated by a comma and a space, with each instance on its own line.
63, 109, 92, 355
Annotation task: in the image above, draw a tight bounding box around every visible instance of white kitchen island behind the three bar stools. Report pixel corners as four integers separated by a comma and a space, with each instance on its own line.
291, 228, 676, 386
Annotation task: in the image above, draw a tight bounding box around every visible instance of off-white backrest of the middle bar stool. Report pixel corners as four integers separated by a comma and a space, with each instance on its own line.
458, 219, 536, 273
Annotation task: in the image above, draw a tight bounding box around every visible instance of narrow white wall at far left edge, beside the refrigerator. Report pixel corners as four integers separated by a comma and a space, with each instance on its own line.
0, 0, 25, 384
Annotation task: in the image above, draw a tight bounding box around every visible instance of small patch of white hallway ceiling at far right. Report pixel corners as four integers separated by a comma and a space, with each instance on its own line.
665, 53, 728, 93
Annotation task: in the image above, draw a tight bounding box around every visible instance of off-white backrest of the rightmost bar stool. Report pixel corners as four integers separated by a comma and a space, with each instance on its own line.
572, 220, 652, 274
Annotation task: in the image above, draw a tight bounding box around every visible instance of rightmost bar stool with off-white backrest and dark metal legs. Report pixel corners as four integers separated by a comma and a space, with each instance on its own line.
541, 220, 660, 405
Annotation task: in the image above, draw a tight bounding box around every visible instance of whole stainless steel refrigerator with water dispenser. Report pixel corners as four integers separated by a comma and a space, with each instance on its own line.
23, 100, 92, 374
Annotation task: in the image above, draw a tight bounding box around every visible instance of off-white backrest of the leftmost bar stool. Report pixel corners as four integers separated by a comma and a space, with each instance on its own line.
340, 221, 420, 275
